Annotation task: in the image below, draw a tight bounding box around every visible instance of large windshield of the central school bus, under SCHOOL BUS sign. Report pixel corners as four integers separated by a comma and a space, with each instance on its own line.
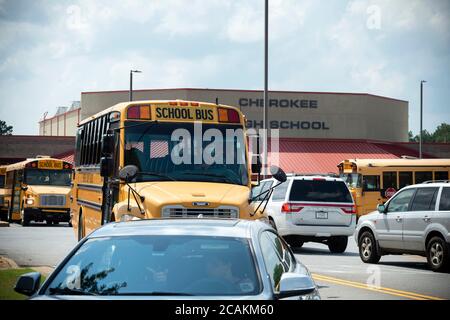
125, 121, 248, 185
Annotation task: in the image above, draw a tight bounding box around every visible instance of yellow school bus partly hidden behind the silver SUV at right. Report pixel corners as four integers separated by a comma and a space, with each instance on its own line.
338, 158, 450, 216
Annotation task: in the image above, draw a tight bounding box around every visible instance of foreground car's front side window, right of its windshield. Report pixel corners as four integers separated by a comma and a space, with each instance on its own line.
260, 231, 285, 292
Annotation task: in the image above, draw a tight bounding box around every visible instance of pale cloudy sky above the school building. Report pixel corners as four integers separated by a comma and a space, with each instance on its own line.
0, 0, 450, 134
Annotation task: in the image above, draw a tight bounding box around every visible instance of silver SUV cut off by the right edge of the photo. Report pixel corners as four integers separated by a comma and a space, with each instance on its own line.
355, 182, 450, 271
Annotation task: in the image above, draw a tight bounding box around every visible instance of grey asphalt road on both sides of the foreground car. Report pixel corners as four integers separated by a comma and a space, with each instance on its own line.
0, 224, 450, 300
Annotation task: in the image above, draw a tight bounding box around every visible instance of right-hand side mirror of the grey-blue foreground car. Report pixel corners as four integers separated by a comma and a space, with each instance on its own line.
277, 272, 316, 299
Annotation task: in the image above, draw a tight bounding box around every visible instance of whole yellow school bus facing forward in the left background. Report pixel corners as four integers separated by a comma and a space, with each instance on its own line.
5, 156, 72, 226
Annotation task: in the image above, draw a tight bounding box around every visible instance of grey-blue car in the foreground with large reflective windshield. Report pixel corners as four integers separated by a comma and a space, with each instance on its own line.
15, 218, 320, 300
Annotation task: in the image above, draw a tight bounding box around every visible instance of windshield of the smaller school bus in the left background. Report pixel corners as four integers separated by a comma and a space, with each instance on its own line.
25, 169, 72, 186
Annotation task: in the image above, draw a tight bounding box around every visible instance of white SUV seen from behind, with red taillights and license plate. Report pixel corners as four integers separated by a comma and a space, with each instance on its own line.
252, 175, 356, 253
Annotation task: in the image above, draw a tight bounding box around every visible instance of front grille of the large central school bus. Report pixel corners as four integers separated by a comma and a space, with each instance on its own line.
162, 206, 239, 218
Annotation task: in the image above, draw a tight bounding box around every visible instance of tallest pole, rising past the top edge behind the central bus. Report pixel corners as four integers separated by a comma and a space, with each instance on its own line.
263, 0, 269, 175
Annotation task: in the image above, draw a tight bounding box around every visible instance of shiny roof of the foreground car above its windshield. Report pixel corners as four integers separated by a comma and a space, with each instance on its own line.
88, 218, 270, 238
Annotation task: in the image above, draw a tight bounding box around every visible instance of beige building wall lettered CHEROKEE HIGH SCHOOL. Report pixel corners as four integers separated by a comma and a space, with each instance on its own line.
80, 89, 408, 142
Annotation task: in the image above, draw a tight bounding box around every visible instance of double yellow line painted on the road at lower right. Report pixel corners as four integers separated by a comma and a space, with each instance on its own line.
313, 274, 445, 300
